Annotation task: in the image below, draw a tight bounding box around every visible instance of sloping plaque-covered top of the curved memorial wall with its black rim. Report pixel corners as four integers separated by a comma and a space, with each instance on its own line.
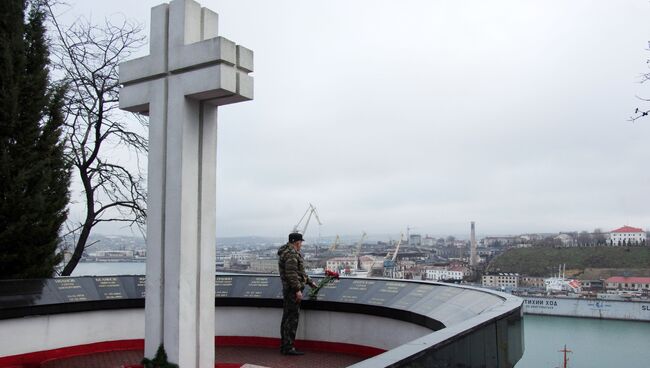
0, 275, 501, 330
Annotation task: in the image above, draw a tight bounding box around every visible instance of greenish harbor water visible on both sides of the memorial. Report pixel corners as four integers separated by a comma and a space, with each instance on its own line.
73, 262, 650, 368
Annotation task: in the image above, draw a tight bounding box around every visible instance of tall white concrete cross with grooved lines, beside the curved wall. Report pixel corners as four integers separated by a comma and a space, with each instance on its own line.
119, 0, 253, 368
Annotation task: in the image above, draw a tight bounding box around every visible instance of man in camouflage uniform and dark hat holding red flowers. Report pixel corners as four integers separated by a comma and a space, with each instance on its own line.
278, 233, 316, 355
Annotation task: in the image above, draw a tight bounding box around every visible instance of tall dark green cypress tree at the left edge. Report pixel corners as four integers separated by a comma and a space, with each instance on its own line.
0, 0, 70, 279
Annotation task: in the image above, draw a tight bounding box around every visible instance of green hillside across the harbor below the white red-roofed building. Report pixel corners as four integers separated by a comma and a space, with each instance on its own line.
487, 247, 650, 277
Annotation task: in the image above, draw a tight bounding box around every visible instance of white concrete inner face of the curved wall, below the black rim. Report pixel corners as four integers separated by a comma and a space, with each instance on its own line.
0, 307, 432, 356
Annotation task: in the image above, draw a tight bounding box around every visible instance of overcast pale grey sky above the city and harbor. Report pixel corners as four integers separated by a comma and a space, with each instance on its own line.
58, 0, 650, 236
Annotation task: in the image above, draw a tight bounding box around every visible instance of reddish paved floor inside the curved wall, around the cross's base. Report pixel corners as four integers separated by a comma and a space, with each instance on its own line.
41, 346, 365, 368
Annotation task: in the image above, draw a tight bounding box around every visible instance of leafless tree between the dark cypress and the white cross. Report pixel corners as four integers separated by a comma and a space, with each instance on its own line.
48, 1, 148, 276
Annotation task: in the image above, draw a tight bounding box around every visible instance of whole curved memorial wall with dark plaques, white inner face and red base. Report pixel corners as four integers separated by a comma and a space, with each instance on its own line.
0, 275, 524, 368
